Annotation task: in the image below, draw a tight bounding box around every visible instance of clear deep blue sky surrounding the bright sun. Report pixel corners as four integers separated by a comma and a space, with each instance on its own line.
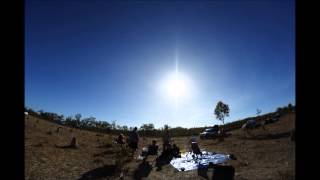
25, 0, 295, 127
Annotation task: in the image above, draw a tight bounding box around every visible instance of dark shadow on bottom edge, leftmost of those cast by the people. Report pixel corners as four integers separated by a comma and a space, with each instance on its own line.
79, 165, 117, 180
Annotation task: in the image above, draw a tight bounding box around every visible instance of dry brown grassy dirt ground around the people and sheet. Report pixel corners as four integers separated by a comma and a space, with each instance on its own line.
25, 113, 295, 180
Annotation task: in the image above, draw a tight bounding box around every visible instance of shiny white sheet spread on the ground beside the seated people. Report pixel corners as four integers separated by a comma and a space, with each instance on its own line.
170, 151, 230, 171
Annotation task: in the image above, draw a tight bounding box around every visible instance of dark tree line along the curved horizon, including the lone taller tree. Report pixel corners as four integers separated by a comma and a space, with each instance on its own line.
25, 102, 295, 137
